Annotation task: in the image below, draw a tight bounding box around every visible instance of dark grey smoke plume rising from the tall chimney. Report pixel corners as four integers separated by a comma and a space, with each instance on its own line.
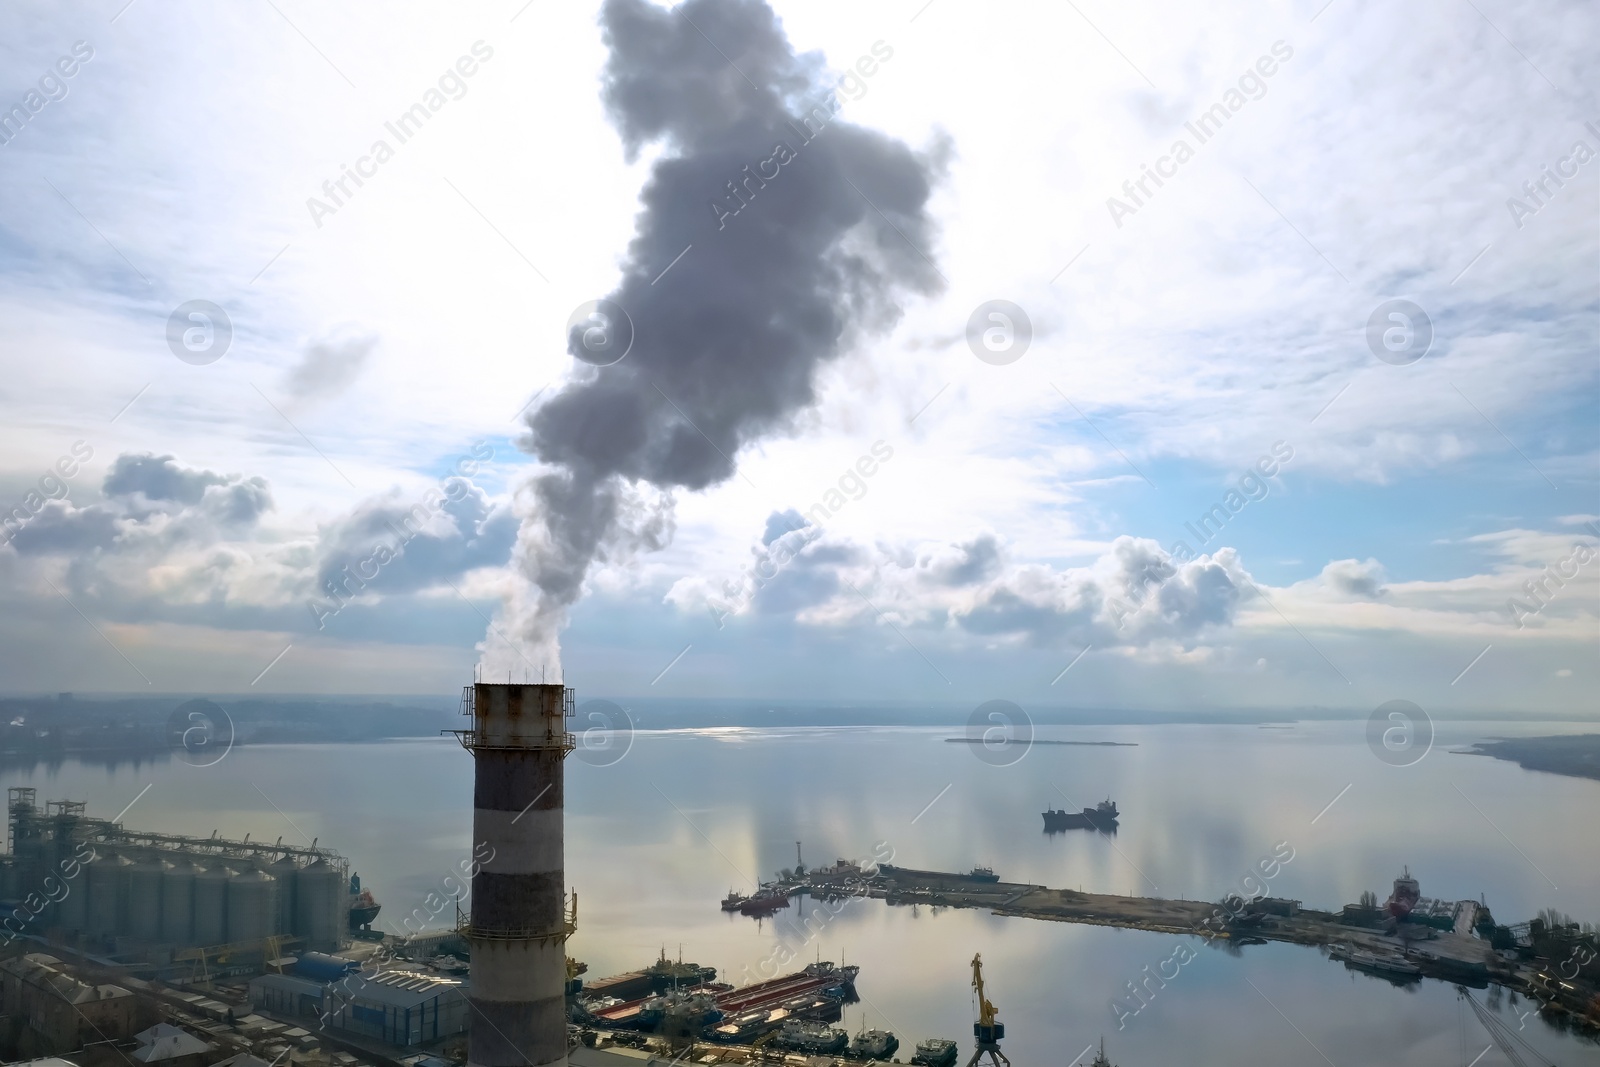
492, 0, 947, 667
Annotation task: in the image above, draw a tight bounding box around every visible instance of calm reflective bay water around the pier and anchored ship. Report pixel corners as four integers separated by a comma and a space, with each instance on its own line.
0, 723, 1600, 1067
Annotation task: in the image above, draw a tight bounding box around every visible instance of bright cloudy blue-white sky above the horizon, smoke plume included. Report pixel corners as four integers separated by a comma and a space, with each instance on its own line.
0, 0, 1600, 717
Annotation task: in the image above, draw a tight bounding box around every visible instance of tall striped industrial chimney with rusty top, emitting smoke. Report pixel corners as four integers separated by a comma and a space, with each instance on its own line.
461, 681, 573, 1067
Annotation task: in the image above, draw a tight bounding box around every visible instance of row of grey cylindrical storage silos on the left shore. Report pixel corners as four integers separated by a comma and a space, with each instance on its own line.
0, 787, 350, 955
